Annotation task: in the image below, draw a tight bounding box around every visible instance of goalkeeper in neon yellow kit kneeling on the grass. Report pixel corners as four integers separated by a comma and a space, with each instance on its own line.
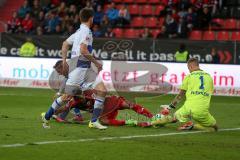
152, 58, 218, 131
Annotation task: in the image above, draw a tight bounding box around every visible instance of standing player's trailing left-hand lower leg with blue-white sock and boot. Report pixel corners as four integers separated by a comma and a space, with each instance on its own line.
41, 95, 70, 128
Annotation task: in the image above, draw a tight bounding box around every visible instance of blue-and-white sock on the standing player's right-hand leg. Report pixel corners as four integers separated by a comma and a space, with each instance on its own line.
91, 98, 105, 122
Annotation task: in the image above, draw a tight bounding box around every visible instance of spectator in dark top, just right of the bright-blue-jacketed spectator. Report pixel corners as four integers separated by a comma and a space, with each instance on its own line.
117, 5, 131, 27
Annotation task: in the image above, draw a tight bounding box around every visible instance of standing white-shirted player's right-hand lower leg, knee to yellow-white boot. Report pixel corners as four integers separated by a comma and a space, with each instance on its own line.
89, 82, 107, 129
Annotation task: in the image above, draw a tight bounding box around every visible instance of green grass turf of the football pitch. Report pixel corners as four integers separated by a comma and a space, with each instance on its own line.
0, 88, 240, 160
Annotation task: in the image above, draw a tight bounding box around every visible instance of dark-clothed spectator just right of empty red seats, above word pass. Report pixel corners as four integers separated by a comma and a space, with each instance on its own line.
165, 14, 177, 38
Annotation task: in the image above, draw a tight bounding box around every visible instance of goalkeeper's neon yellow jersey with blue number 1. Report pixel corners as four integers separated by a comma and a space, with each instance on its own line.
181, 70, 213, 111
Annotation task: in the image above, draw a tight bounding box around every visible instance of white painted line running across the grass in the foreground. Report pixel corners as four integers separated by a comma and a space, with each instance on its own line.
0, 128, 240, 148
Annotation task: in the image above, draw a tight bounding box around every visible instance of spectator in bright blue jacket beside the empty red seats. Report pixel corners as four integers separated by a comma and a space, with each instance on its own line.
106, 2, 118, 26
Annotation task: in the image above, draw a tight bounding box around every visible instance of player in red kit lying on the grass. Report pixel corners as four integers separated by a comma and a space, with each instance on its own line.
56, 90, 153, 127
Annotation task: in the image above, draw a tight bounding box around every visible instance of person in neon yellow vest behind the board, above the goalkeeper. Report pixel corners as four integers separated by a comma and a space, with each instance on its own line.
174, 43, 189, 62
